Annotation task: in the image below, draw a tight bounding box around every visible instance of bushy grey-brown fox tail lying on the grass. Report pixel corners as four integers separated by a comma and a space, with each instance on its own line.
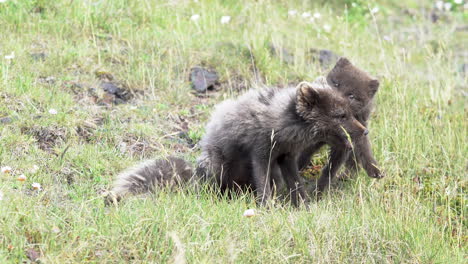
106, 157, 193, 204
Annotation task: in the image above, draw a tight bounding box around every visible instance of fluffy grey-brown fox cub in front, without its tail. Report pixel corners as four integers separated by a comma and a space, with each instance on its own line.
198, 82, 367, 205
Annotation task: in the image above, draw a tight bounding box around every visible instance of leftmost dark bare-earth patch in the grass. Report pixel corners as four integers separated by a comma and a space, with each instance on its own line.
21, 127, 66, 153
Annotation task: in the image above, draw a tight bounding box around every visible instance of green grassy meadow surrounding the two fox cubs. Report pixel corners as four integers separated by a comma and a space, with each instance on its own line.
0, 0, 468, 263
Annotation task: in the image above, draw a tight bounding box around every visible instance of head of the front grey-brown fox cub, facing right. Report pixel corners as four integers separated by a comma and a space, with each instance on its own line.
296, 82, 369, 149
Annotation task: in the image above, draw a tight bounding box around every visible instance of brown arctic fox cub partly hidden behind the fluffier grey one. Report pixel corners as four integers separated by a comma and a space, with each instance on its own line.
298, 57, 383, 186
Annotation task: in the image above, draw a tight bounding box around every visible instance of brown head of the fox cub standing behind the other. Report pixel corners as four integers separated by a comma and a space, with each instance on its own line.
327, 57, 379, 114
